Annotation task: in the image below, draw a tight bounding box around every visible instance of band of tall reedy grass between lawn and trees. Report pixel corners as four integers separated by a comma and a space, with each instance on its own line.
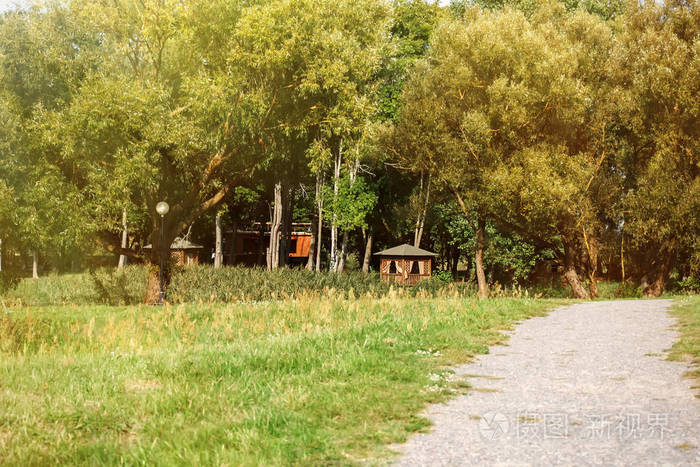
3, 265, 640, 306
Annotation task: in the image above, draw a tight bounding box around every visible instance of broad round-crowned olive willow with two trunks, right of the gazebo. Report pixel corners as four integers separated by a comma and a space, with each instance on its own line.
393, 2, 614, 297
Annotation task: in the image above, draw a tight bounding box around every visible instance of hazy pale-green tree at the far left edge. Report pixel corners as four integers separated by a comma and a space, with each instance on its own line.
0, 8, 96, 277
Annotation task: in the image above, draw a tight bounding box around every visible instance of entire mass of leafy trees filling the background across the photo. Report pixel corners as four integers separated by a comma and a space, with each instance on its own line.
0, 0, 700, 297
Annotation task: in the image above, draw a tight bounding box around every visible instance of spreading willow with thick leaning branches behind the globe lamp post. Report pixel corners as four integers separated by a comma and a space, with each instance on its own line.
31, 0, 266, 301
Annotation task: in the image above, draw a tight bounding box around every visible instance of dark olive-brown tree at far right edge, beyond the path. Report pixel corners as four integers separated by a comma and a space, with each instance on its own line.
611, 1, 700, 296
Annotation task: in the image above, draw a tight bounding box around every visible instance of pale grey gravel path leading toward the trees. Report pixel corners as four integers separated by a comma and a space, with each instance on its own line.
394, 300, 700, 466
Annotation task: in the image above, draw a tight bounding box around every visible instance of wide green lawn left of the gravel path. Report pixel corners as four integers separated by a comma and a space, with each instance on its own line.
0, 294, 559, 465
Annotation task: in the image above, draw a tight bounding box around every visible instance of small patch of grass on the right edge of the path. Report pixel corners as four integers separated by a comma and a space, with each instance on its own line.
669, 295, 700, 397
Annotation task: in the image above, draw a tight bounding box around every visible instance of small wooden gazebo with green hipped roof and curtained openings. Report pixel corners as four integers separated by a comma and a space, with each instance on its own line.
375, 243, 437, 285
